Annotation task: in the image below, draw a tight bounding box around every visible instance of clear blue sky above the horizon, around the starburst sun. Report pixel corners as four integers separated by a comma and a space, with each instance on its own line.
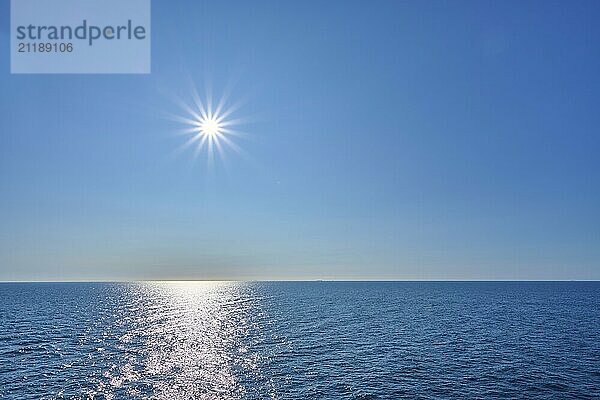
0, 0, 600, 280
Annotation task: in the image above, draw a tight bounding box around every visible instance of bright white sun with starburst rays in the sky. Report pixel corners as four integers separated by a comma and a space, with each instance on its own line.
167, 81, 245, 167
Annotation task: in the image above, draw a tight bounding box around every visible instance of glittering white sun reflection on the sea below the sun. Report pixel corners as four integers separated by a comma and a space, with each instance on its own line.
99, 282, 268, 399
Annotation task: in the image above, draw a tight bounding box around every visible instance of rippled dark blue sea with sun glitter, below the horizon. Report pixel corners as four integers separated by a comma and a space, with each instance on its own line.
0, 282, 600, 399
